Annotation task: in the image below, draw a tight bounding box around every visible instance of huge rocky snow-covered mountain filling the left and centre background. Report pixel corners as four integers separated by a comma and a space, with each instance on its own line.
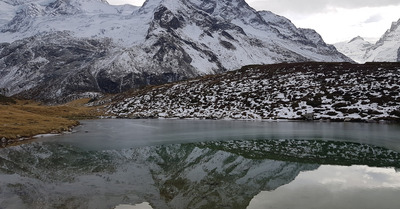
0, 0, 351, 100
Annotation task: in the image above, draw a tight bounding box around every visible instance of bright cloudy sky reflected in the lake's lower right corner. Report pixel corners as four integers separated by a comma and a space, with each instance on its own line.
247, 166, 400, 209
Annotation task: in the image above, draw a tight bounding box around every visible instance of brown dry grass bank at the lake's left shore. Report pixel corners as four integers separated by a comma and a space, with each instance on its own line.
0, 99, 101, 139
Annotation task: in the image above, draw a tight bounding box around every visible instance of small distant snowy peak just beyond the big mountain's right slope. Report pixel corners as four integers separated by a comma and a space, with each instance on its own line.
335, 36, 373, 63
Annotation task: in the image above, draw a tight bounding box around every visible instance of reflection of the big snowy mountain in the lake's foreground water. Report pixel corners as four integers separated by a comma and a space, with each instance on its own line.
0, 138, 400, 208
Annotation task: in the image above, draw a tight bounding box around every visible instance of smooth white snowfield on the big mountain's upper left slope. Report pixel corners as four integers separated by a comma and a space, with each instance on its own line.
0, 0, 145, 45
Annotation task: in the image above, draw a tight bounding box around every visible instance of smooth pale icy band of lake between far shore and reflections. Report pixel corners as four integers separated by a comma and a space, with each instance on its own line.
46, 119, 400, 152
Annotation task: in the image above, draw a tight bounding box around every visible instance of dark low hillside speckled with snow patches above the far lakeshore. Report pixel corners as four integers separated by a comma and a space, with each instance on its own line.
108, 63, 400, 121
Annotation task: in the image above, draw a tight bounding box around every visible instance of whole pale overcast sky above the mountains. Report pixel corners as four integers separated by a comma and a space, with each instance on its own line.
107, 0, 400, 44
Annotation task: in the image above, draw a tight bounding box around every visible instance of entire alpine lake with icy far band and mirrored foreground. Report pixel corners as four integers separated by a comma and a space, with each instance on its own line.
0, 119, 400, 209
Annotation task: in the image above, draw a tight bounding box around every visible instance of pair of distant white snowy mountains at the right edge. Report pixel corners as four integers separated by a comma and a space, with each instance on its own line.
335, 19, 400, 63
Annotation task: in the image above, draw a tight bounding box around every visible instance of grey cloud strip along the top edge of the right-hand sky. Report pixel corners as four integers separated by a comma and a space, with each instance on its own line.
247, 0, 400, 13
